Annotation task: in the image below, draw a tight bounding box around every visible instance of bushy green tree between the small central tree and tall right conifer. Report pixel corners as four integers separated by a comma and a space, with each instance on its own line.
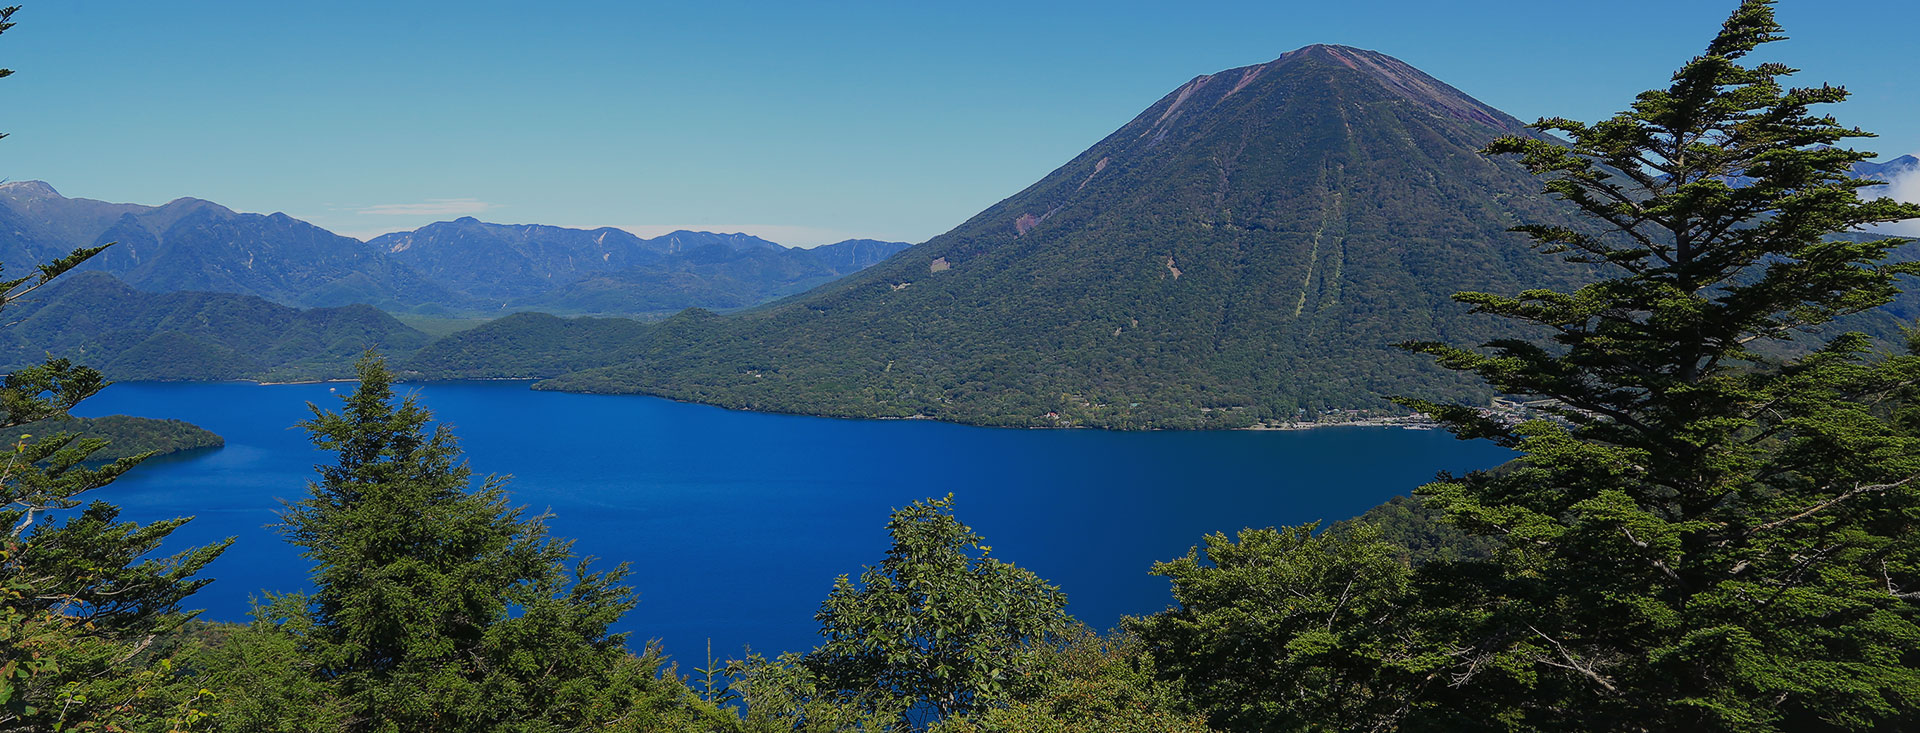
1127, 524, 1411, 731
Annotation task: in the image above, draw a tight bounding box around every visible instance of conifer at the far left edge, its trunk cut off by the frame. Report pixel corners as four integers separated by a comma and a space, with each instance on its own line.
0, 8, 227, 731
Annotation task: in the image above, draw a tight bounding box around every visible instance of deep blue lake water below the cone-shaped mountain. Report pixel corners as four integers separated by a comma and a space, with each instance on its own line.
77, 382, 1507, 666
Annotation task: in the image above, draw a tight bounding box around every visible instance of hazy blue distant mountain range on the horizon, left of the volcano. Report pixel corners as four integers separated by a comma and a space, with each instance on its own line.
0, 180, 908, 315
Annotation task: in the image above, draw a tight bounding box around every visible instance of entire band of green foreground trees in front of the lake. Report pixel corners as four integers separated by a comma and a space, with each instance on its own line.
0, 0, 1920, 733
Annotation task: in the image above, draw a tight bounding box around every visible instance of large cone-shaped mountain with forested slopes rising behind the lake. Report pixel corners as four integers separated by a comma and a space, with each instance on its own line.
420, 46, 1584, 428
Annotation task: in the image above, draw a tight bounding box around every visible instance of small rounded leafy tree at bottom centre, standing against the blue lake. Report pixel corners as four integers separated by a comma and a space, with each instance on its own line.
737, 497, 1069, 731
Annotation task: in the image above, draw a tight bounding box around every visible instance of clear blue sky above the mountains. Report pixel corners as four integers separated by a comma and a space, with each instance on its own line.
0, 0, 1920, 244
